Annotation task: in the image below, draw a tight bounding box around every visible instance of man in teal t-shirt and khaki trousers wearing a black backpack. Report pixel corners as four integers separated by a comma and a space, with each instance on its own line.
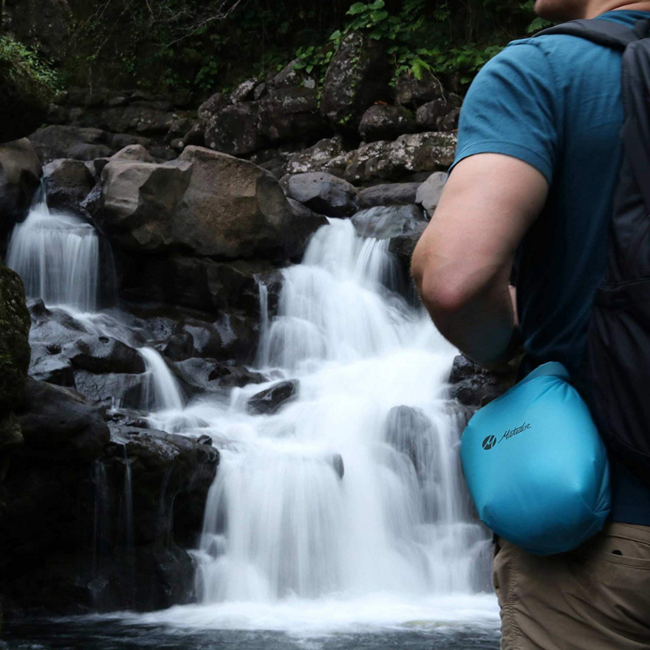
412, 0, 650, 650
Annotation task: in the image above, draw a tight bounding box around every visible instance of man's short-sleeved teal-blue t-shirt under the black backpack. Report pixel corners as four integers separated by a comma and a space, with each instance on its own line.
454, 11, 650, 525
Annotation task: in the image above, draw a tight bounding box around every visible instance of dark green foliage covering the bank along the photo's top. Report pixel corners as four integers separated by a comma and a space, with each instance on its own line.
68, 0, 546, 95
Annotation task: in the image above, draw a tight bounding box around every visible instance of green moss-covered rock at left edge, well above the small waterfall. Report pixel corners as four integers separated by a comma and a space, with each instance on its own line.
0, 36, 56, 142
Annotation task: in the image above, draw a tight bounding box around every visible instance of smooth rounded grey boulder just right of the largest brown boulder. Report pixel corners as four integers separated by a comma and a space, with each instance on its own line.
287, 172, 359, 217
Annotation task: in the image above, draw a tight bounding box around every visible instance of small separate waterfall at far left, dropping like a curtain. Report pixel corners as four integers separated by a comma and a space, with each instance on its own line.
7, 192, 100, 312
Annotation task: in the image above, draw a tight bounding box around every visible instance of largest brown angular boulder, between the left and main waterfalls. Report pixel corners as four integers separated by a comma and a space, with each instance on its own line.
93, 147, 323, 259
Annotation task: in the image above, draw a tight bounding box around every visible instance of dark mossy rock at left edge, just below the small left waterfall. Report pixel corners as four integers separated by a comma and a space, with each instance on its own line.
0, 264, 31, 408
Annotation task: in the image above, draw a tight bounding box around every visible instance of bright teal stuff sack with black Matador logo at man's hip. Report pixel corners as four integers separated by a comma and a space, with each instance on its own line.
461, 362, 610, 555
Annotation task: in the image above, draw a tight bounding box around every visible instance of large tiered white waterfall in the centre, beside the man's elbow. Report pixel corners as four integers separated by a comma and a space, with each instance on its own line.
179, 220, 489, 624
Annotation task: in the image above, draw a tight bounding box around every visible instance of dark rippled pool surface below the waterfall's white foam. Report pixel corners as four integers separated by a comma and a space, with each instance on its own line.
0, 619, 499, 650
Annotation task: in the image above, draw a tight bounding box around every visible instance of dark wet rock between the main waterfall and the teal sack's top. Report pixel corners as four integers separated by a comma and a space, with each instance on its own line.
449, 355, 517, 406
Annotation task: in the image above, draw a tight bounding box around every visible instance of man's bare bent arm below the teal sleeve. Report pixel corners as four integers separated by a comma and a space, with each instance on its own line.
411, 154, 548, 366
